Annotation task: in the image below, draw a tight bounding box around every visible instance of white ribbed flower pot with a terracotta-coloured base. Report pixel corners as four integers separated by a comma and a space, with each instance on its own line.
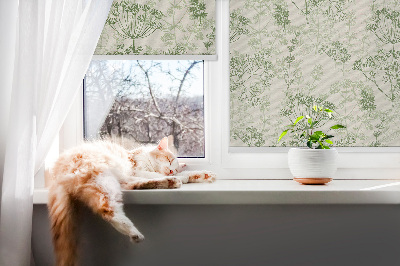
288, 148, 338, 185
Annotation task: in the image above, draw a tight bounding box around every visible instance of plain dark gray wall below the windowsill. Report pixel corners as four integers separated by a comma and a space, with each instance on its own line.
32, 204, 400, 266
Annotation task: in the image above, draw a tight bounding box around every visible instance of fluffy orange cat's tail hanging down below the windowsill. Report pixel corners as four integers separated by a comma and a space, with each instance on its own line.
48, 182, 77, 266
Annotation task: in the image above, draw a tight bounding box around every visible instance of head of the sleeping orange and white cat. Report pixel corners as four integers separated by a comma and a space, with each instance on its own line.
149, 137, 179, 175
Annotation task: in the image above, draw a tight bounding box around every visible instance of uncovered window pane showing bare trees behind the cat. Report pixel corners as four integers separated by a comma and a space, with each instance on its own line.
84, 60, 204, 157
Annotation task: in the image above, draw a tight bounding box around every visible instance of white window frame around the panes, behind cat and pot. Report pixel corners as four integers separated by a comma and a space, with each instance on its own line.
60, 0, 400, 179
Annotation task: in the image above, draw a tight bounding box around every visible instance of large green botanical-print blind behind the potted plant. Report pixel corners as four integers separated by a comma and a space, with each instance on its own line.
230, 0, 400, 147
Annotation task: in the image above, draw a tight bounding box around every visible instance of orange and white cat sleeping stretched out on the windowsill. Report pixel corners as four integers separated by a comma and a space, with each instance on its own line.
48, 137, 216, 266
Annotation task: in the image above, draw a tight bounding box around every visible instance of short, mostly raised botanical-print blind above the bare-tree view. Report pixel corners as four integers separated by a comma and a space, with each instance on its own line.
95, 0, 215, 55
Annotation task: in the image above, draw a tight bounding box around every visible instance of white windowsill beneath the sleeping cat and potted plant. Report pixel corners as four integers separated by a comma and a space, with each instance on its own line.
33, 180, 400, 204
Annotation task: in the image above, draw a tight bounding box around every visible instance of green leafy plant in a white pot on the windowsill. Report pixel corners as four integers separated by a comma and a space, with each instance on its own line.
278, 105, 345, 185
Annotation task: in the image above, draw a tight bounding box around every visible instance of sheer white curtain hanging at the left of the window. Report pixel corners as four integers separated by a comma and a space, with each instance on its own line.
0, 0, 112, 265
